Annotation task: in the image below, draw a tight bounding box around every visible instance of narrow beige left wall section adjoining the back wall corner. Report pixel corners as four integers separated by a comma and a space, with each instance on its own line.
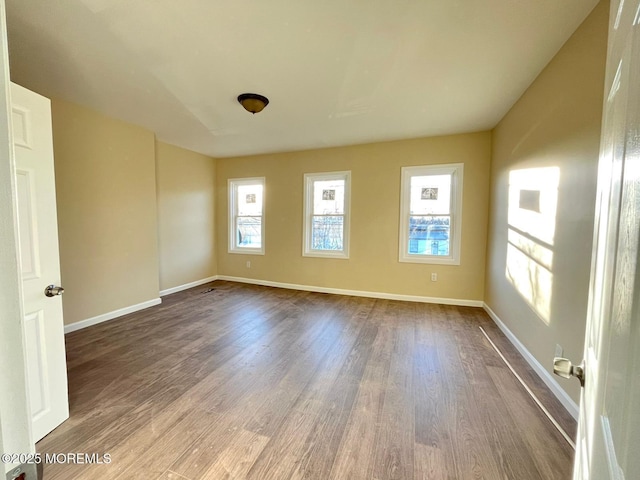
156, 142, 216, 290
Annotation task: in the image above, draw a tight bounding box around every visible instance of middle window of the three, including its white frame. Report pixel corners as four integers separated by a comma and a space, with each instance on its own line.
302, 172, 351, 258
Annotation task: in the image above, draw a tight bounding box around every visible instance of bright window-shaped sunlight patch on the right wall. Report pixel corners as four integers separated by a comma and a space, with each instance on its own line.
505, 167, 560, 325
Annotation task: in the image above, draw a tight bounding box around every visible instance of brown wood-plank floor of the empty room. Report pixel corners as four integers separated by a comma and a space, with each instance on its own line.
37, 281, 575, 480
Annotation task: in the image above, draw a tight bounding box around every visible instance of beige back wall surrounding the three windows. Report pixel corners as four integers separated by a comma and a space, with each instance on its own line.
216, 132, 491, 300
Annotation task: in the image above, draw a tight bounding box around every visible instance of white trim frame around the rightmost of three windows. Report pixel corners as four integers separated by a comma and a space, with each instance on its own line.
399, 163, 464, 265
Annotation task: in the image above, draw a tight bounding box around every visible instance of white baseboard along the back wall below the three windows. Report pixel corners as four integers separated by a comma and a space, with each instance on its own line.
218, 275, 483, 307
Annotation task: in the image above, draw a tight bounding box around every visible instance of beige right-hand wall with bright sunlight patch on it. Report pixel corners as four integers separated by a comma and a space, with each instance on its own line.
485, 2, 608, 402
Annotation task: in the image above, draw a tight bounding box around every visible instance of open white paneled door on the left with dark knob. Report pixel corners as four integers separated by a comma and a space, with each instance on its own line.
11, 84, 69, 442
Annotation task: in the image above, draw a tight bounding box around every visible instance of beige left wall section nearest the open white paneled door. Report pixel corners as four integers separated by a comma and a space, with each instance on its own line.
52, 100, 158, 324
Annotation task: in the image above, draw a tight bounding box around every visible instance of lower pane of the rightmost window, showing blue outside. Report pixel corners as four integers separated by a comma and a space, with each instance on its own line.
409, 216, 451, 255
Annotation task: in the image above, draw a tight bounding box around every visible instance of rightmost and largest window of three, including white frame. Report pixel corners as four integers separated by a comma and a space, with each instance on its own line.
400, 163, 463, 265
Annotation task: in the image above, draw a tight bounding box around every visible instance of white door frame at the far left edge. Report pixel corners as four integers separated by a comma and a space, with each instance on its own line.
0, 0, 35, 478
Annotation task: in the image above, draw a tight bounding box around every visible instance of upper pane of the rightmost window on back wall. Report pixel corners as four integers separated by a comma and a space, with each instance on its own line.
410, 175, 451, 215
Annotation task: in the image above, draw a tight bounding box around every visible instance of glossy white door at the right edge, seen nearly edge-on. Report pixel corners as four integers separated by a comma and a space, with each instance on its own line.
574, 0, 640, 480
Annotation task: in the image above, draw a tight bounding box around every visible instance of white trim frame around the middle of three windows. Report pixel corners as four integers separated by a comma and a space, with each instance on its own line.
302, 171, 351, 259
